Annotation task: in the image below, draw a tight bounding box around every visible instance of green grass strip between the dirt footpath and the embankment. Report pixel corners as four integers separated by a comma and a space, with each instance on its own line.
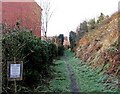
65, 51, 117, 92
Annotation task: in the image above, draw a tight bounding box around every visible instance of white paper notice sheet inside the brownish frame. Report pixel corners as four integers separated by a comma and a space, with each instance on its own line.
10, 64, 20, 78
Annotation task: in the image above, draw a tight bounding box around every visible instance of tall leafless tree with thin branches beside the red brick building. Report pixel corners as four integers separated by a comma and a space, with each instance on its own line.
42, 0, 53, 38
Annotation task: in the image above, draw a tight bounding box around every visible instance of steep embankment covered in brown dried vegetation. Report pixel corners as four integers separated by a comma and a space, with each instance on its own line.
75, 13, 120, 75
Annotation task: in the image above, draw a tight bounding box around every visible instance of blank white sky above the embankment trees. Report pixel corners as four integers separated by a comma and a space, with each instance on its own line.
35, 0, 120, 36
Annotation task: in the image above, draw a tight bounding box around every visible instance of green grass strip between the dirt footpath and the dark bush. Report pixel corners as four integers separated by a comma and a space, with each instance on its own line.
46, 58, 70, 92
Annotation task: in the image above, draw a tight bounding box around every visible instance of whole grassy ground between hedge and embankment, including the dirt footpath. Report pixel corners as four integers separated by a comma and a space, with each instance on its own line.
45, 50, 116, 94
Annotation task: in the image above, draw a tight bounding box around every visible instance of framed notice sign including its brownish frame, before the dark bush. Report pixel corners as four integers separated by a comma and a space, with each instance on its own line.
7, 61, 23, 81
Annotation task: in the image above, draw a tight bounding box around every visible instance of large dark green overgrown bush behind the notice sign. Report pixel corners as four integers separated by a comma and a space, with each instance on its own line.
2, 29, 63, 92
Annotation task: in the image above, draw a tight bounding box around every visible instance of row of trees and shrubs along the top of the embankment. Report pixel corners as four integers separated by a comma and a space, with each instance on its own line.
69, 13, 108, 50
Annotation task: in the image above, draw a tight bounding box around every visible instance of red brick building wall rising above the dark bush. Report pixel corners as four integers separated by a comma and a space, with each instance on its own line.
2, 0, 42, 37
